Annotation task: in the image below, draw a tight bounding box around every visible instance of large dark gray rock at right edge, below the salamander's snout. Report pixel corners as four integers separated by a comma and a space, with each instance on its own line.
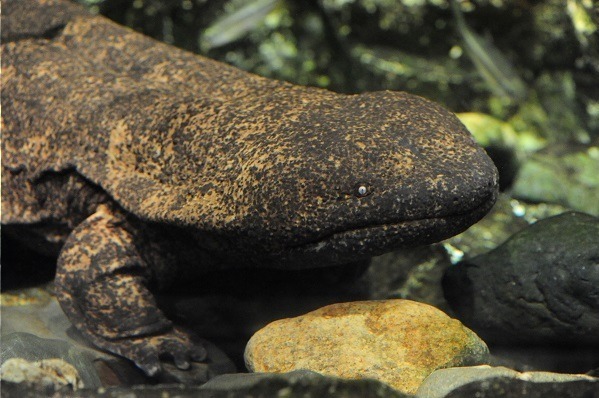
443, 212, 599, 345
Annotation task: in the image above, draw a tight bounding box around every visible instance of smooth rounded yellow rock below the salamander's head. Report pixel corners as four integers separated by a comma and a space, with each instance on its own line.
245, 300, 489, 394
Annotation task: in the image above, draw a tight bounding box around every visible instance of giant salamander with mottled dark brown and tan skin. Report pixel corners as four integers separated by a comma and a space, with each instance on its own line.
2, 0, 497, 375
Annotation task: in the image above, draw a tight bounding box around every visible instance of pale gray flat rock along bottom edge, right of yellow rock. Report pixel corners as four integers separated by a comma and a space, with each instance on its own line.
416, 366, 599, 398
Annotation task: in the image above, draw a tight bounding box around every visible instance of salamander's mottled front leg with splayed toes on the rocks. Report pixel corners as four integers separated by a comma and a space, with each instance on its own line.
56, 206, 206, 376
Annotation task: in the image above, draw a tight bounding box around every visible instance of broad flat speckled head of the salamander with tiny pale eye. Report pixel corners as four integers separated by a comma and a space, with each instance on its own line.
220, 88, 498, 266
